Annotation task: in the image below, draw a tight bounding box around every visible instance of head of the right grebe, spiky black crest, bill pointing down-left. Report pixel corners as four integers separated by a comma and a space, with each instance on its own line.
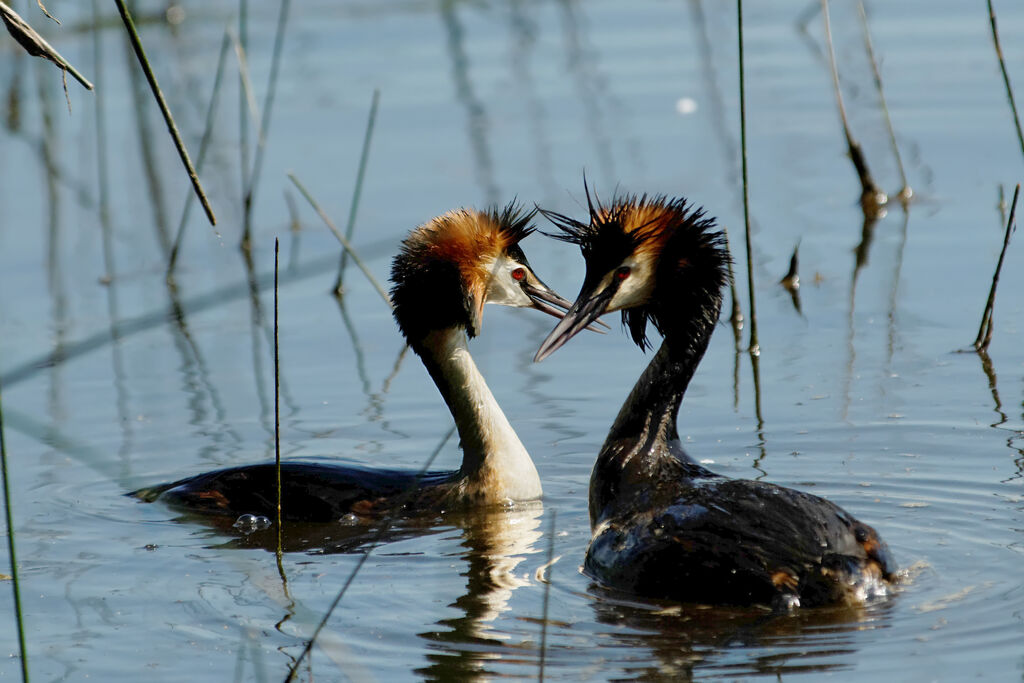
534, 184, 730, 361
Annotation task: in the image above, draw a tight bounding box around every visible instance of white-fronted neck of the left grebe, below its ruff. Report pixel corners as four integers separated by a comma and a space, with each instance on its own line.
418, 328, 542, 503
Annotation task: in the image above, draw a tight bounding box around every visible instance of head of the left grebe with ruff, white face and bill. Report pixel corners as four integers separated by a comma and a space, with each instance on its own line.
391, 202, 570, 342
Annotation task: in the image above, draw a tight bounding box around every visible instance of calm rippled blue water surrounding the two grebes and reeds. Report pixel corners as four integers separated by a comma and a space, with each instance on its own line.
0, 0, 1024, 681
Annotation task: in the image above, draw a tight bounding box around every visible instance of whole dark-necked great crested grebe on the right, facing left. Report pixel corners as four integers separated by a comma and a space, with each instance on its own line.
535, 191, 895, 609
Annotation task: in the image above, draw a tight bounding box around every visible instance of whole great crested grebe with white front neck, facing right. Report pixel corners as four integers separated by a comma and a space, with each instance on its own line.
129, 202, 585, 521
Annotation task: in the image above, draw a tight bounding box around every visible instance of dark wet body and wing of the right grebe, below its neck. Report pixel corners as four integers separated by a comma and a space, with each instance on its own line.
586, 479, 894, 606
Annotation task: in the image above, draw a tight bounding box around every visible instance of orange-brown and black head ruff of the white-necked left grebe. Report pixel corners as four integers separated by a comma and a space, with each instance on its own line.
391, 202, 535, 342
